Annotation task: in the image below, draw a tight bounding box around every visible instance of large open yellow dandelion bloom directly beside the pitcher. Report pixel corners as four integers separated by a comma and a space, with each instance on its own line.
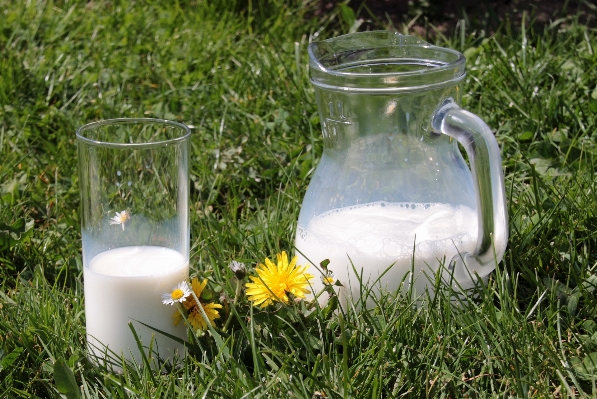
245, 251, 313, 308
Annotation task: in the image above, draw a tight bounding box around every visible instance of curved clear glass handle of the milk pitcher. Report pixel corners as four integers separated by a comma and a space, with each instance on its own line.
432, 98, 508, 281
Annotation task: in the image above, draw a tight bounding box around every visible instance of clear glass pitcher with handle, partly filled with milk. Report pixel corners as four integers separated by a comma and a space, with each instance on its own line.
295, 31, 508, 304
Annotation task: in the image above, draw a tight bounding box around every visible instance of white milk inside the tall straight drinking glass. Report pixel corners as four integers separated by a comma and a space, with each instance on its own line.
83, 246, 189, 368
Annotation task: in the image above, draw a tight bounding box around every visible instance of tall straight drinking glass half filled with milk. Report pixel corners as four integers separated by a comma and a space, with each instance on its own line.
77, 118, 190, 370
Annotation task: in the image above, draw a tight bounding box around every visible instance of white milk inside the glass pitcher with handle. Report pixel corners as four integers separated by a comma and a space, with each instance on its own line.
295, 202, 477, 306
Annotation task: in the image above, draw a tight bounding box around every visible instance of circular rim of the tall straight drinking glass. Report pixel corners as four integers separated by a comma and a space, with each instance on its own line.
76, 118, 191, 148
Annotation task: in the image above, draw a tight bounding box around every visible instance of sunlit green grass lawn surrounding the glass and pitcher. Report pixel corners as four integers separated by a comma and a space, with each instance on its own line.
0, 0, 597, 398
